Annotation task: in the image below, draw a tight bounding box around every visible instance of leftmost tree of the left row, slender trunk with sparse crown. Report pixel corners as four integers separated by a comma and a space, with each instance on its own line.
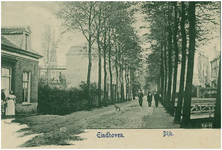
57, 2, 96, 110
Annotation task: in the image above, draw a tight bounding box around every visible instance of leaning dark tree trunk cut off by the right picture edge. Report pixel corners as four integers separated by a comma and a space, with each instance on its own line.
213, 61, 221, 128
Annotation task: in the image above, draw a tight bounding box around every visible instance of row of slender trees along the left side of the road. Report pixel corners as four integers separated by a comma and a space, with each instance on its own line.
57, 1, 141, 110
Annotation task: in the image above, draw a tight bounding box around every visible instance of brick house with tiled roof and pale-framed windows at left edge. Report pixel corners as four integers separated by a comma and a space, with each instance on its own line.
1, 27, 42, 113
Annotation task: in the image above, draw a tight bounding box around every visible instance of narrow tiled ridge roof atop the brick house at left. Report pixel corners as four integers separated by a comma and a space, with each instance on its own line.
1, 26, 31, 35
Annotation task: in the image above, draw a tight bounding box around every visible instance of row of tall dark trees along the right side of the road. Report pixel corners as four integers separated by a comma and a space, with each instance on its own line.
142, 2, 220, 127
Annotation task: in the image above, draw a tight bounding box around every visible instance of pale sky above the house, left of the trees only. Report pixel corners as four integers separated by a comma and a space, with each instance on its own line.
1, 2, 85, 66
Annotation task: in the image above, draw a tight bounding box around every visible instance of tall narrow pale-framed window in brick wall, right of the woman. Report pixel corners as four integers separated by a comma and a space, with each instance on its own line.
22, 72, 31, 102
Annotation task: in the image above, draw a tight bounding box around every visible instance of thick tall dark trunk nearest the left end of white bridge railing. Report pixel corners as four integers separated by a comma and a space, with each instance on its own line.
181, 2, 196, 128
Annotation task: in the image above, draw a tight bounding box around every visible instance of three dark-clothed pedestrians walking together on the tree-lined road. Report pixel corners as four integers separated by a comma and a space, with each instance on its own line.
139, 90, 160, 107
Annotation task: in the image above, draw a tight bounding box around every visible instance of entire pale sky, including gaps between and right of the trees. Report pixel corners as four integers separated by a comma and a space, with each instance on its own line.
1, 1, 220, 66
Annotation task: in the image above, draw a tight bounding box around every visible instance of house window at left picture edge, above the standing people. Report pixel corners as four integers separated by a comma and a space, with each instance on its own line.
1, 67, 12, 96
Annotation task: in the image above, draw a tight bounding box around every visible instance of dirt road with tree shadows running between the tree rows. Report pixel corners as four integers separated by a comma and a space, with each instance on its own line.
2, 97, 179, 148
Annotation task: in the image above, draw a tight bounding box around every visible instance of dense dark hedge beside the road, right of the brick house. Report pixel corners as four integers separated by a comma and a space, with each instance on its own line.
38, 82, 97, 115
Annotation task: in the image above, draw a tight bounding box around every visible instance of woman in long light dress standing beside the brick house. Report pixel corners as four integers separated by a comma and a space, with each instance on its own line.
5, 91, 16, 116
